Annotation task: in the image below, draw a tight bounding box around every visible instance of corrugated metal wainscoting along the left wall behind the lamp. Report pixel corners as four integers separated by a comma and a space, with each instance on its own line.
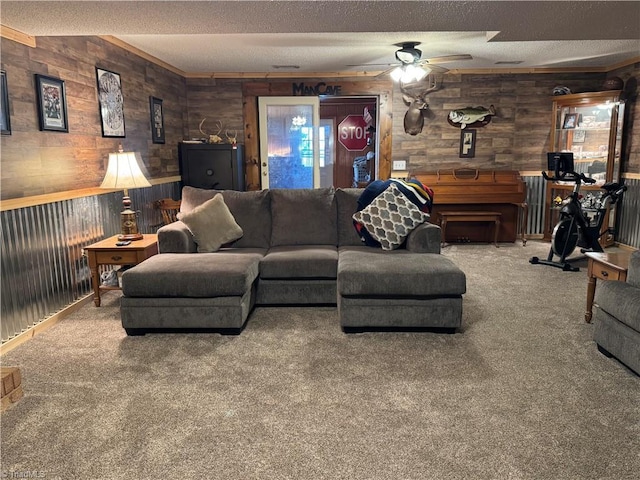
0, 182, 180, 342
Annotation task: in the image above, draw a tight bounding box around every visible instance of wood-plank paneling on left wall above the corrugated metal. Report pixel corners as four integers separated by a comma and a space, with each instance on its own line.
1, 37, 187, 200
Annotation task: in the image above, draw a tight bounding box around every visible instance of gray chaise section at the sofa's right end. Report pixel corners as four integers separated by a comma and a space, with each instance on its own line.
337, 247, 466, 333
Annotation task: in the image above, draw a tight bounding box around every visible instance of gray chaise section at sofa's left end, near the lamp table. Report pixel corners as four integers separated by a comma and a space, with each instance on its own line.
120, 252, 262, 335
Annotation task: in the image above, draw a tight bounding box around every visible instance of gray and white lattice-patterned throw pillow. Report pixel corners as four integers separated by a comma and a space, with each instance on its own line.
353, 184, 429, 250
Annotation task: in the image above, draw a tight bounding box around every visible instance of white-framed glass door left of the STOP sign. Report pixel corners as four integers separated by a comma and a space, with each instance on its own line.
258, 97, 320, 188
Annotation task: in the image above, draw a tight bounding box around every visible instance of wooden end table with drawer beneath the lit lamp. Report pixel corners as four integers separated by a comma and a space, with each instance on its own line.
84, 233, 158, 307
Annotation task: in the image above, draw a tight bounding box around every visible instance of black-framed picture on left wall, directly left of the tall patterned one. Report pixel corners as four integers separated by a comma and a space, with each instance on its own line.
36, 74, 69, 132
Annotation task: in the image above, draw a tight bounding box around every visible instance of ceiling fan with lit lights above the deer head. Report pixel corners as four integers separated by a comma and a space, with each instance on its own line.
348, 42, 473, 82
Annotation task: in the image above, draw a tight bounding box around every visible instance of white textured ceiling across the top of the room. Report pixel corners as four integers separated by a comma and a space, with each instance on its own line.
1, 0, 640, 75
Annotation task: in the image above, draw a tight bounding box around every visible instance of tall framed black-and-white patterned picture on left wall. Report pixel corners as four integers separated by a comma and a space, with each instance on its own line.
96, 67, 125, 137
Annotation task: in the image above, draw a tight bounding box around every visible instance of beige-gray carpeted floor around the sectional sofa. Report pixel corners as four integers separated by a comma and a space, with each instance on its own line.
1, 241, 640, 480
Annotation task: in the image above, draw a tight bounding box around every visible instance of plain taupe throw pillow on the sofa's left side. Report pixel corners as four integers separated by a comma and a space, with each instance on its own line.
178, 194, 243, 253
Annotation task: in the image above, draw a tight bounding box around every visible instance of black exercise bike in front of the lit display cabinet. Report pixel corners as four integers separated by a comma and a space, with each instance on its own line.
529, 168, 627, 272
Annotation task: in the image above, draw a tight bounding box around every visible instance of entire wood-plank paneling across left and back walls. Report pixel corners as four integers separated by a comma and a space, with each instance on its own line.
0, 32, 640, 200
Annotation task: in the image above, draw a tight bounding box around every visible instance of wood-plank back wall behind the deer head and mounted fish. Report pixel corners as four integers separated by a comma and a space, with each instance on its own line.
393, 74, 624, 171
